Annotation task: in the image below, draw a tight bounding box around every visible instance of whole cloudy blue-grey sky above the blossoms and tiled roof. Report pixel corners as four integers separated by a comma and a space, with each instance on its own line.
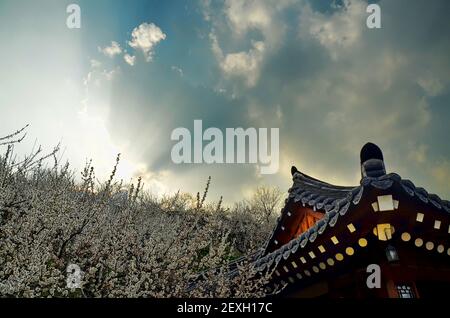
0, 0, 450, 202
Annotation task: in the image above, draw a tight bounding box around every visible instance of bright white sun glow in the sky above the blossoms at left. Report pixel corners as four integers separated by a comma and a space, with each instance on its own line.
0, 3, 151, 194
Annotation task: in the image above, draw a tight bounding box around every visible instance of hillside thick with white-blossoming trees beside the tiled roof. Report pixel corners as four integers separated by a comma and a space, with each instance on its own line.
0, 130, 280, 297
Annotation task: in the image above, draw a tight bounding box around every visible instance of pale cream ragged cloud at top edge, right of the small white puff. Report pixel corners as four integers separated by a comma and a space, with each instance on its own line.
203, 0, 295, 87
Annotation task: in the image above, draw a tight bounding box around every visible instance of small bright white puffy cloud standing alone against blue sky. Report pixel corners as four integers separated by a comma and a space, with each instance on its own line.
128, 23, 166, 62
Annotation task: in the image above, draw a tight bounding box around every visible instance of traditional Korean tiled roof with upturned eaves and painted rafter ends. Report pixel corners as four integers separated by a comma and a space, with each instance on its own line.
256, 144, 450, 292
